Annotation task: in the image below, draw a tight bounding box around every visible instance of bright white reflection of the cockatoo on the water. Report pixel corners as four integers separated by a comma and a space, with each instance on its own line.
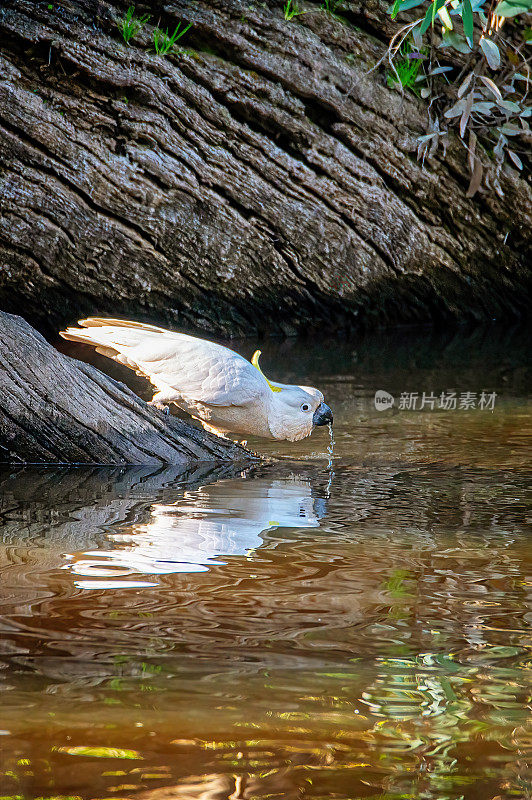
63, 478, 324, 589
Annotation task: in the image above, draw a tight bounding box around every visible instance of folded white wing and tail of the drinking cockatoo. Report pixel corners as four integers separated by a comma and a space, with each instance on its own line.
61, 317, 270, 406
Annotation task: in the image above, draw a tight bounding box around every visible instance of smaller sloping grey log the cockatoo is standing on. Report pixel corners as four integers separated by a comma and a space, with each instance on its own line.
0, 312, 254, 467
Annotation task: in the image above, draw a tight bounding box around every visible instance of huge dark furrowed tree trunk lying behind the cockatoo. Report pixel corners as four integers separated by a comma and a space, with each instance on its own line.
0, 0, 531, 335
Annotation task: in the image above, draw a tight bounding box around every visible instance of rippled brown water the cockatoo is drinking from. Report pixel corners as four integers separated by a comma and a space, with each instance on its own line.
0, 329, 532, 800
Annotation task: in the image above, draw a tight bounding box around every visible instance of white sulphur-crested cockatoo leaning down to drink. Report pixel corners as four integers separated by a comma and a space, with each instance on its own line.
60, 317, 333, 442
